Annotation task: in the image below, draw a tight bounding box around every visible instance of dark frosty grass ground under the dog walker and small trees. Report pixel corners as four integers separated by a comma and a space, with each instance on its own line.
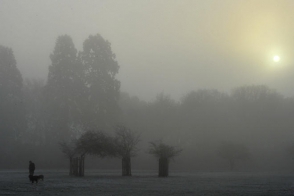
0, 170, 294, 196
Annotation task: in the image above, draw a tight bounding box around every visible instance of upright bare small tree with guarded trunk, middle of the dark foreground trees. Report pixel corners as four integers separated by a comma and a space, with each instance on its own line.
115, 125, 140, 176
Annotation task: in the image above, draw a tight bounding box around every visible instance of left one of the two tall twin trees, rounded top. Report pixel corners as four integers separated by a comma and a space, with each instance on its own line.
45, 35, 84, 140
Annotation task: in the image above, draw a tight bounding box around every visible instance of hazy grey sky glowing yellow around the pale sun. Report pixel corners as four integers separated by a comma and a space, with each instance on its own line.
0, 0, 294, 100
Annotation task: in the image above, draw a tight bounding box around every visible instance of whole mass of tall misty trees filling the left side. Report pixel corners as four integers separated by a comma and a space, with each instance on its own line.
0, 34, 120, 167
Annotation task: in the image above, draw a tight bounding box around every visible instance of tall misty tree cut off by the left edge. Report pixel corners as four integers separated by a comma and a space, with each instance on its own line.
0, 45, 26, 144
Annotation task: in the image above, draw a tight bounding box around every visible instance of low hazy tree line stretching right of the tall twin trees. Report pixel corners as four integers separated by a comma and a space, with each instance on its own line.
120, 85, 294, 170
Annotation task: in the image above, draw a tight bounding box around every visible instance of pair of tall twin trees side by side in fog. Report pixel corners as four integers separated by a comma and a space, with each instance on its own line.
44, 35, 120, 141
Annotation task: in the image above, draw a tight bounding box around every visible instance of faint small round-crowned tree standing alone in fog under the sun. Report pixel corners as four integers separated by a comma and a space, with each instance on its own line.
218, 141, 250, 170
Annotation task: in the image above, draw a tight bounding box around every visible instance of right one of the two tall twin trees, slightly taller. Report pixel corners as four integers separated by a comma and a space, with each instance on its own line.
80, 34, 120, 129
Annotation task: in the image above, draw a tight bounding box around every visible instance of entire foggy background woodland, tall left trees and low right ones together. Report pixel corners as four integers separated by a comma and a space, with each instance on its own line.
0, 34, 294, 172
